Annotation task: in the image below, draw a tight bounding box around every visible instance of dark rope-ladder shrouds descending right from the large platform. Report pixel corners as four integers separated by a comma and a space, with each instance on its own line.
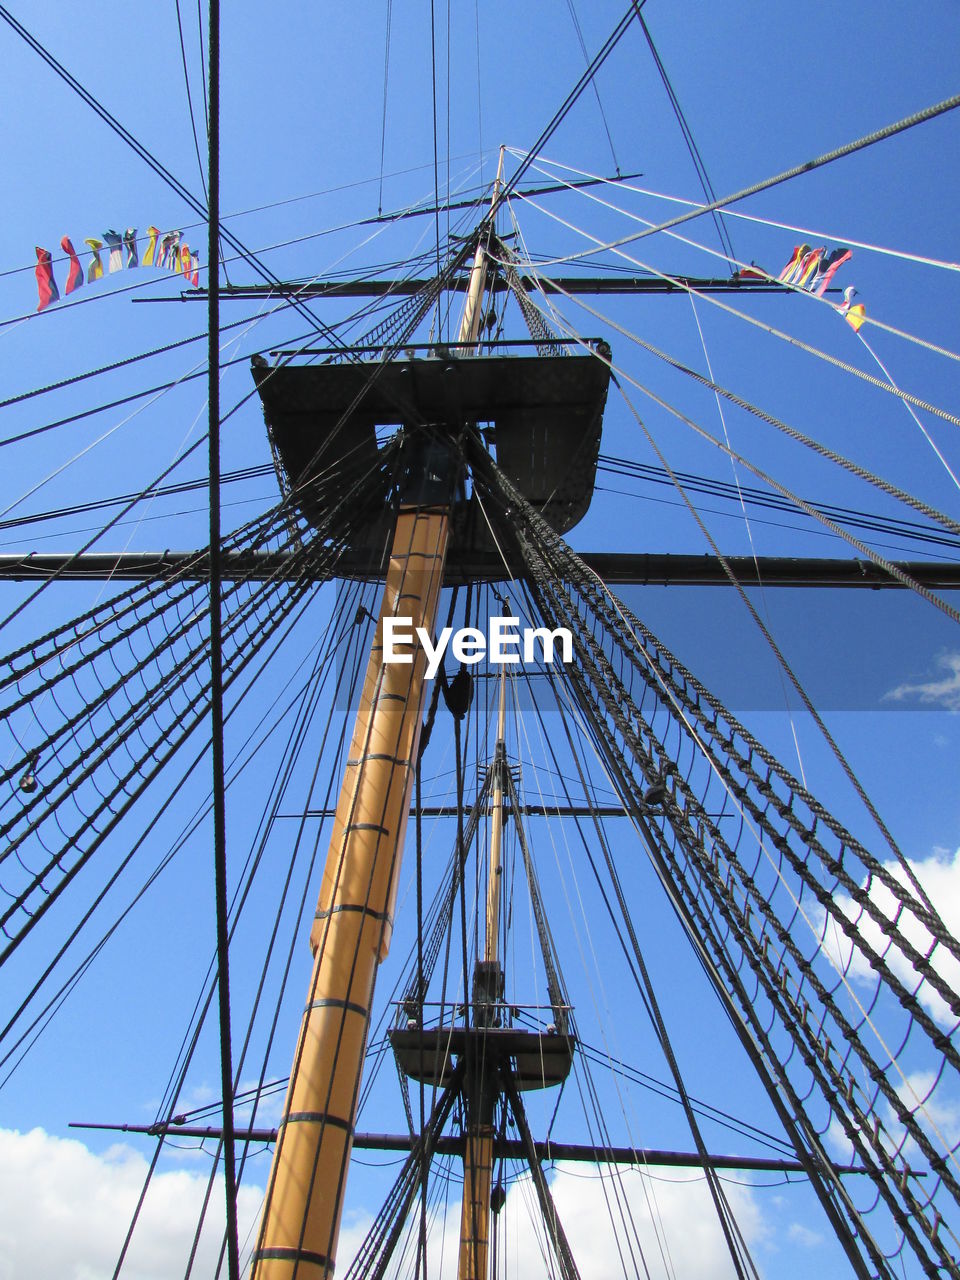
474, 437, 960, 1275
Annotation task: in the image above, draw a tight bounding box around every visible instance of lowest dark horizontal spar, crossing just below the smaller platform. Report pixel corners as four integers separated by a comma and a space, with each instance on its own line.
70, 1124, 880, 1176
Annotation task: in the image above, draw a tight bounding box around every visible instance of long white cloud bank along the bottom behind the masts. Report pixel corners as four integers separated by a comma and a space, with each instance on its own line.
0, 1129, 773, 1280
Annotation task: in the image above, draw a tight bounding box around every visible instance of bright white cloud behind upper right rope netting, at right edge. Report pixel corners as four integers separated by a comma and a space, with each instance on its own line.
819, 849, 960, 1027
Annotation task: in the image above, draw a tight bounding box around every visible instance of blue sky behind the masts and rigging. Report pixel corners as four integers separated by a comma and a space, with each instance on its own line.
0, 0, 960, 1280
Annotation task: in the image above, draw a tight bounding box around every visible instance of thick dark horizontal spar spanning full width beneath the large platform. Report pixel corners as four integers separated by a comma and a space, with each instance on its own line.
0, 552, 960, 591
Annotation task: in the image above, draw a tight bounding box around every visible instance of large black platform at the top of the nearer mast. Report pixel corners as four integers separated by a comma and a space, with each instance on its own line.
252, 340, 611, 576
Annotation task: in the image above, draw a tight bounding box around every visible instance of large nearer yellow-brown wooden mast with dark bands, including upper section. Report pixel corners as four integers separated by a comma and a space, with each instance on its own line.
251, 172, 503, 1280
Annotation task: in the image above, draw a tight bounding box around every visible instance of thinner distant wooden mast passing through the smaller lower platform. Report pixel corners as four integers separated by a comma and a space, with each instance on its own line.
457, 667, 507, 1280
